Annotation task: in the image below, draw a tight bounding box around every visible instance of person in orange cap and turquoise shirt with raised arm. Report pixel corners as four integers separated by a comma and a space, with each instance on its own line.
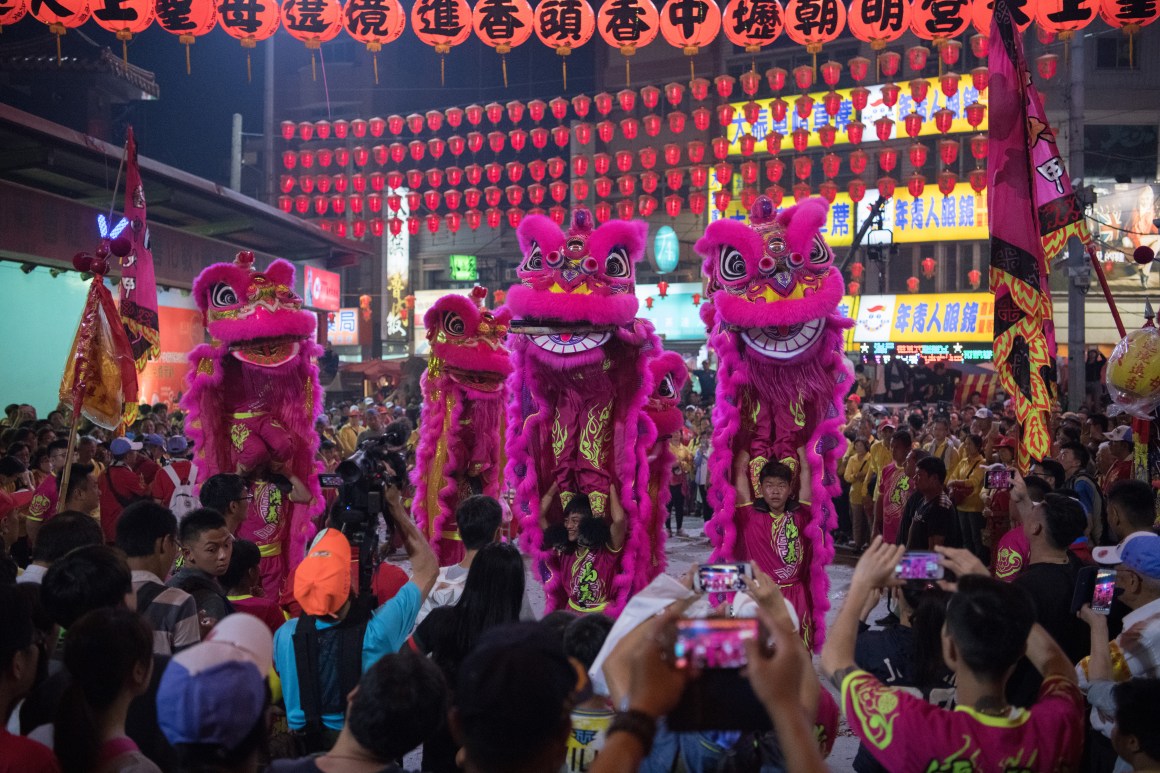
274, 481, 438, 754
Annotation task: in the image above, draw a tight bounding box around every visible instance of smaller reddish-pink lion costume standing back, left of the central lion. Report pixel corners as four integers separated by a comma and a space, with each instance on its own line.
413, 287, 512, 566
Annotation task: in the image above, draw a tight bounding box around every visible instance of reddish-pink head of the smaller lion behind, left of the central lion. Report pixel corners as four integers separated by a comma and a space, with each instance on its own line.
423, 287, 512, 392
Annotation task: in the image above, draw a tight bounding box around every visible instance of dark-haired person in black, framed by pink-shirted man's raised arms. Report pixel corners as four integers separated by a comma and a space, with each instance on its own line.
854, 581, 955, 773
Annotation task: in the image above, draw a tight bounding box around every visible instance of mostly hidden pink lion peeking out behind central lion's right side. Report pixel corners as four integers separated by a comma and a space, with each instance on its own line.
637, 352, 689, 580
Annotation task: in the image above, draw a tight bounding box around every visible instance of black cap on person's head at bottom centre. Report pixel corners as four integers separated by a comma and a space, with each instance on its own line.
455, 622, 592, 746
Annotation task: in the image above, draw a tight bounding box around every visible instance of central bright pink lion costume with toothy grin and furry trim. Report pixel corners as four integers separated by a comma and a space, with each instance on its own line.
507, 209, 659, 614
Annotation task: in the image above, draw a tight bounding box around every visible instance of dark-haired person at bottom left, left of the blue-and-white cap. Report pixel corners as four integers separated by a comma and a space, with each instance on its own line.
52, 607, 161, 773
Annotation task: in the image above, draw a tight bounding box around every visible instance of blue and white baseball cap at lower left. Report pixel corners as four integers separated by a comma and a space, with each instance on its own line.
157, 613, 274, 749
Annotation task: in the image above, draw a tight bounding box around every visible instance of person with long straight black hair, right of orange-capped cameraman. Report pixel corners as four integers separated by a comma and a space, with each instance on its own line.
411, 542, 524, 773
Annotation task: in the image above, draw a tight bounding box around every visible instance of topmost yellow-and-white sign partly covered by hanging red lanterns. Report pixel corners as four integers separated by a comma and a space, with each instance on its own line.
727, 74, 987, 156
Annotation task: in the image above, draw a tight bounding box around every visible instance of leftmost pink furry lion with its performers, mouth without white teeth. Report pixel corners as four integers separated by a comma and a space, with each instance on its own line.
181, 252, 324, 599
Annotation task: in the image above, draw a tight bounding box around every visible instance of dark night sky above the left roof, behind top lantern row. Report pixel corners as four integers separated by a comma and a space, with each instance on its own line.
0, 15, 600, 185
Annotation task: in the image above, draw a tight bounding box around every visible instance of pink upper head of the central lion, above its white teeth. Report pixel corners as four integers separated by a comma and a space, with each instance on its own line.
507, 209, 648, 325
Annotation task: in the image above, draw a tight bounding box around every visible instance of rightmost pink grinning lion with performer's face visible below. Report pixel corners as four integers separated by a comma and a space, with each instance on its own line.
696, 196, 853, 650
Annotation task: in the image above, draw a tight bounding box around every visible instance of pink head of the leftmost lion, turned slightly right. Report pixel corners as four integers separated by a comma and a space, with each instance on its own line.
194, 251, 318, 368
